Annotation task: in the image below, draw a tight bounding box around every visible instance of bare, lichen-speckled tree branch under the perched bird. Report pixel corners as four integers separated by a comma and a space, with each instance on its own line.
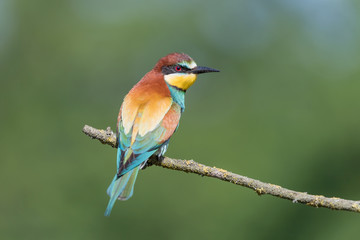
83, 125, 360, 213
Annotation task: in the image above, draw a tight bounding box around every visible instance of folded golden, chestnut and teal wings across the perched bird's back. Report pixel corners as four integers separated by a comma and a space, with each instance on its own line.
117, 98, 181, 176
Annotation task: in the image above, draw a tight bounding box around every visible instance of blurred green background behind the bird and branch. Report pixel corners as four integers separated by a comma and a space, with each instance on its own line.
0, 0, 360, 239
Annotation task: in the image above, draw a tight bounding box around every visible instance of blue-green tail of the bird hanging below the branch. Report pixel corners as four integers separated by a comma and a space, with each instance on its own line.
105, 167, 139, 216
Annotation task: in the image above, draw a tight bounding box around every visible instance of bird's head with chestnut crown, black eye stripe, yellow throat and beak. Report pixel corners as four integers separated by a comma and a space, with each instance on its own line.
154, 53, 219, 91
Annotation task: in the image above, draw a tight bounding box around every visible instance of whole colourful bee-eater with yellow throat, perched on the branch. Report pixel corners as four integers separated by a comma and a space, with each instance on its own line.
105, 52, 219, 216
